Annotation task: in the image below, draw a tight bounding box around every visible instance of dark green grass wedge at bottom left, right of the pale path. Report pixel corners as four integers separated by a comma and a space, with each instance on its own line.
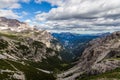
9, 61, 55, 80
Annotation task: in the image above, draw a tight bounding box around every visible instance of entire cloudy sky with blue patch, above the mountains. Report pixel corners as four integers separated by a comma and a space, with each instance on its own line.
0, 0, 120, 34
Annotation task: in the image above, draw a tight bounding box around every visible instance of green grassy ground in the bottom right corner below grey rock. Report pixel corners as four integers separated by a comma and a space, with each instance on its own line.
78, 68, 120, 80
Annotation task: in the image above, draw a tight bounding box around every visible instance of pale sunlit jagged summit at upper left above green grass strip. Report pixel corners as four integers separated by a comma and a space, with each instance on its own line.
0, 17, 35, 32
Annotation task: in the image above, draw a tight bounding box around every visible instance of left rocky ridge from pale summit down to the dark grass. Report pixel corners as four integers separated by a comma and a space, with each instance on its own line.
0, 17, 61, 61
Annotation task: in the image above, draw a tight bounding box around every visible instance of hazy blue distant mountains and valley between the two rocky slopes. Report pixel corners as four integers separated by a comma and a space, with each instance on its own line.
52, 32, 103, 60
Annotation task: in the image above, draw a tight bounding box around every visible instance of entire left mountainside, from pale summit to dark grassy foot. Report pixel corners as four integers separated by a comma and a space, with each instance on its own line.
0, 17, 67, 80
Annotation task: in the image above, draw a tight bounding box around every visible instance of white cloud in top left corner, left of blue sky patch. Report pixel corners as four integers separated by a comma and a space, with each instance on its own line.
0, 0, 30, 18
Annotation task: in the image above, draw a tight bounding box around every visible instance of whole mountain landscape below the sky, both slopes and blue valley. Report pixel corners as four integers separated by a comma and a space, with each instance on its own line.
0, 17, 120, 80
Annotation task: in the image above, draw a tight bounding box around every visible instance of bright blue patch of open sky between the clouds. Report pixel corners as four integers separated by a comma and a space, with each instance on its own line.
14, 1, 56, 21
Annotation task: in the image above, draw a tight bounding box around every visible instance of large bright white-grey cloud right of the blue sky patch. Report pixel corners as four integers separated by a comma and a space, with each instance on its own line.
43, 0, 120, 20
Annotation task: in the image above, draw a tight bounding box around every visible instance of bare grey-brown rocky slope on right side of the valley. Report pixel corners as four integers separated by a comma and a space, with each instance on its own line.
58, 32, 120, 80
